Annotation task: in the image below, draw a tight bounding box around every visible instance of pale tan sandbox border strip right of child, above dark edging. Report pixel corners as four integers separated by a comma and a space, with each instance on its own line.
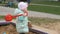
32, 25, 58, 34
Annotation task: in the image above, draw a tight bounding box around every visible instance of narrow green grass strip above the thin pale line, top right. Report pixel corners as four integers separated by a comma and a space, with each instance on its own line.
31, 0, 60, 6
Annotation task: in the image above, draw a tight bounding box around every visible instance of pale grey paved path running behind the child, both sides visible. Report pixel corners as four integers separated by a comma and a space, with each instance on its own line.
0, 6, 60, 19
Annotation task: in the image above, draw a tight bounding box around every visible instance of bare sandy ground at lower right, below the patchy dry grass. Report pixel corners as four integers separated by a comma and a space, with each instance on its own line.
34, 22, 60, 34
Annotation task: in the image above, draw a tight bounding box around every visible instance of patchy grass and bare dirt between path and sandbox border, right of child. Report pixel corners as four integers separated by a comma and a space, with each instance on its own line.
30, 18, 60, 34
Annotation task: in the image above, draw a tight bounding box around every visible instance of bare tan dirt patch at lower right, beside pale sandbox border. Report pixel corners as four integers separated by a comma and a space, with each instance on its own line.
41, 22, 60, 34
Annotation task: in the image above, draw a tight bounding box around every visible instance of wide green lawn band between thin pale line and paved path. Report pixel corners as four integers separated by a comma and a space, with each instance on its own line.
28, 5, 60, 15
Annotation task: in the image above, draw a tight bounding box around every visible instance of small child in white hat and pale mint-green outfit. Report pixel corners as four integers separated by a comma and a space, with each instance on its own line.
15, 0, 29, 34
